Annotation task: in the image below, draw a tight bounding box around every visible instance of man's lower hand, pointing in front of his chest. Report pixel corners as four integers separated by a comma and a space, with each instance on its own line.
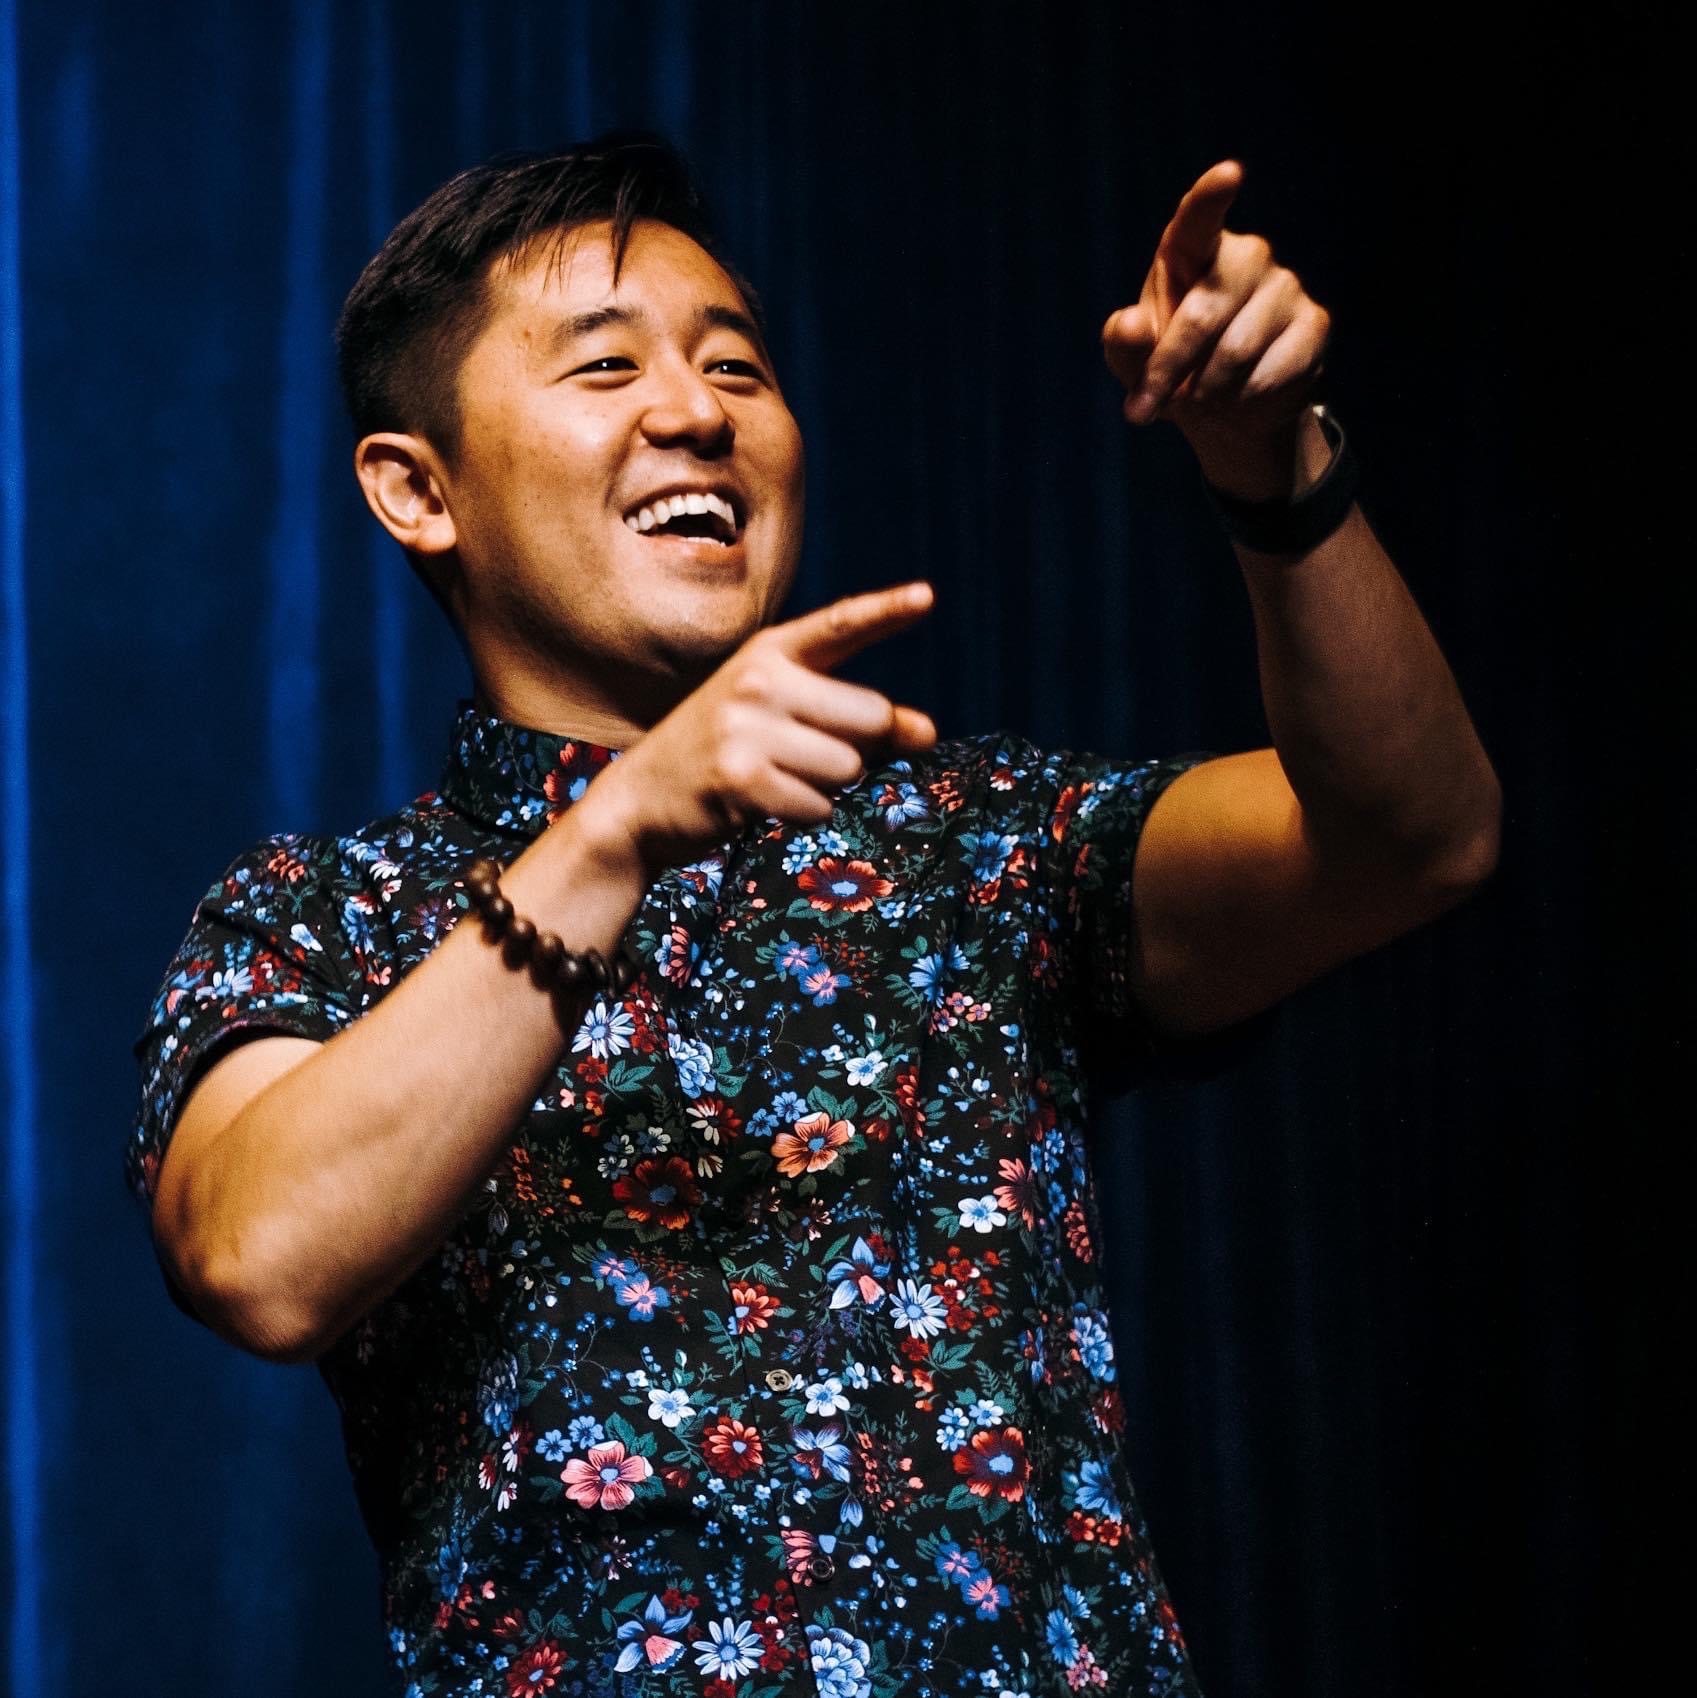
572, 582, 938, 880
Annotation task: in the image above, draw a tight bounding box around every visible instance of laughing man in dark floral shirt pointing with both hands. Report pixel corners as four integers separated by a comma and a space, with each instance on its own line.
131, 138, 1498, 1698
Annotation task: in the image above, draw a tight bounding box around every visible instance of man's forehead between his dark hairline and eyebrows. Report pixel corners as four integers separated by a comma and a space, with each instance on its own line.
489, 219, 746, 351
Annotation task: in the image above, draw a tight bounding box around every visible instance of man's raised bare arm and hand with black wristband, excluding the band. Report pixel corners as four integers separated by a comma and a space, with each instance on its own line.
1102, 161, 1502, 1032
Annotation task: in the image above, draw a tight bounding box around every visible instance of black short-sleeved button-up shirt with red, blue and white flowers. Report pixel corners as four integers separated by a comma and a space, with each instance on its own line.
127, 706, 1204, 1698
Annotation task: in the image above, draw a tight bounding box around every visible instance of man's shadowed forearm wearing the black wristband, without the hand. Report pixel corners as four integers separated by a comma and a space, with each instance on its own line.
1203, 418, 1500, 883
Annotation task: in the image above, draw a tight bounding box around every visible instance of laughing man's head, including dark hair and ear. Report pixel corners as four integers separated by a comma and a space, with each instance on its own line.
338, 136, 803, 740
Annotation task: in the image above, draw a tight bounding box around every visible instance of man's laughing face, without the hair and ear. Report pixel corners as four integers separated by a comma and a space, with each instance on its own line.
445, 221, 803, 710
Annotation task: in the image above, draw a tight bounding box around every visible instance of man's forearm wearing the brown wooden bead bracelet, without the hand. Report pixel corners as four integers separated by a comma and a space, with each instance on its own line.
177, 813, 644, 1358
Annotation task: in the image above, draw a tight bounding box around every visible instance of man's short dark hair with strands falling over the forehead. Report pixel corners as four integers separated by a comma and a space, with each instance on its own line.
336, 129, 764, 460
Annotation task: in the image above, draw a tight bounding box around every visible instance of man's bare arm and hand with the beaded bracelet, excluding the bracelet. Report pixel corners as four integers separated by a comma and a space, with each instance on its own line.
153, 586, 936, 1362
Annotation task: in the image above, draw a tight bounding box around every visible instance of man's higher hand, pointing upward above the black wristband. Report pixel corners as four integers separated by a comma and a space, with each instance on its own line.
1102, 160, 1332, 447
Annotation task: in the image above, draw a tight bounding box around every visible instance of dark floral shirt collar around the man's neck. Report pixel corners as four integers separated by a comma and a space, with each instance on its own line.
437, 701, 618, 837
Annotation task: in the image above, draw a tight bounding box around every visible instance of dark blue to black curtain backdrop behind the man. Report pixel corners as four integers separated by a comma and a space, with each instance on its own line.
0, 0, 1697, 1698
